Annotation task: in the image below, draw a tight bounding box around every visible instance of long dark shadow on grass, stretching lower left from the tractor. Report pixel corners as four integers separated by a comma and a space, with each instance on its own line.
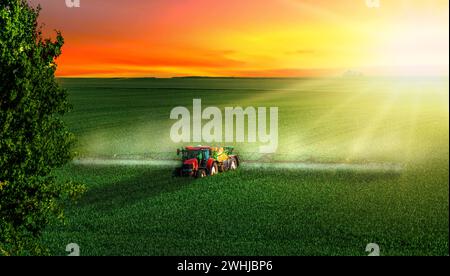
77, 169, 195, 211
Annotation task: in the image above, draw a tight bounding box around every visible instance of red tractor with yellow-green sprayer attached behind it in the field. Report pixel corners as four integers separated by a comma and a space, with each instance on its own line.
176, 146, 240, 178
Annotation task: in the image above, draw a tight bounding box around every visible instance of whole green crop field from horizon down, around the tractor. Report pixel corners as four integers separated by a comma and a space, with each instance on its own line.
44, 78, 449, 255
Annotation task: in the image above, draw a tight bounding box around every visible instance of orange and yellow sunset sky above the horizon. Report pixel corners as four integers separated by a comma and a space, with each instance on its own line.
29, 0, 449, 77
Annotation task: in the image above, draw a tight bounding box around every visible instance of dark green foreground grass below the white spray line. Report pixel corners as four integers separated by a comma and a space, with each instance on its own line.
43, 161, 448, 255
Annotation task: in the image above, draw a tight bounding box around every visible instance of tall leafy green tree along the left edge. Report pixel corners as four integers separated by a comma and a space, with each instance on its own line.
0, 0, 84, 255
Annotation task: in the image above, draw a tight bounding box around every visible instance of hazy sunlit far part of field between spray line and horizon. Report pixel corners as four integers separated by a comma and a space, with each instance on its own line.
62, 78, 449, 163
